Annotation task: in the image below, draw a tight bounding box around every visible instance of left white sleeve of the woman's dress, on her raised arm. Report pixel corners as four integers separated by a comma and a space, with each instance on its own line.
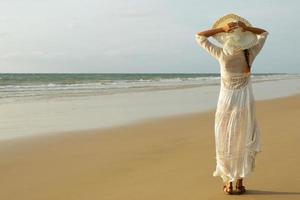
195, 34, 222, 59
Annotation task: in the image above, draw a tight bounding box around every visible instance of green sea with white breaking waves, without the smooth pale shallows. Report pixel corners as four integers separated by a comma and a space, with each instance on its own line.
0, 73, 300, 104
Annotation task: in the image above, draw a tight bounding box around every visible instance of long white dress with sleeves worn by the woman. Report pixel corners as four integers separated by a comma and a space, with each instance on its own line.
196, 32, 269, 182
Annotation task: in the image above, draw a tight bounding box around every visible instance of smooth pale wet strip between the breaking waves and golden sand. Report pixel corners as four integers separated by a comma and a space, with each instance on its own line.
0, 76, 300, 141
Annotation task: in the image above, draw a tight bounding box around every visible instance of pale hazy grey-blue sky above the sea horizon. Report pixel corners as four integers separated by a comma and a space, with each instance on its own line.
0, 0, 300, 73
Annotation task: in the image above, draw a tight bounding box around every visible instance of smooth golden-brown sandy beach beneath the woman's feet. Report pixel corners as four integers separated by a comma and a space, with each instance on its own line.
0, 95, 300, 200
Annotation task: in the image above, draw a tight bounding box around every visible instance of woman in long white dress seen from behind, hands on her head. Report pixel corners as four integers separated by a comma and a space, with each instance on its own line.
196, 14, 268, 194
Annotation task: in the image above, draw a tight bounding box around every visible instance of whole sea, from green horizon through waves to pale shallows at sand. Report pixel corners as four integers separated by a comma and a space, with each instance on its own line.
0, 74, 300, 140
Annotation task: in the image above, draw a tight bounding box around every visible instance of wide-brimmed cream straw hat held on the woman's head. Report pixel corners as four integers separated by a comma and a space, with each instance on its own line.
213, 13, 257, 51
